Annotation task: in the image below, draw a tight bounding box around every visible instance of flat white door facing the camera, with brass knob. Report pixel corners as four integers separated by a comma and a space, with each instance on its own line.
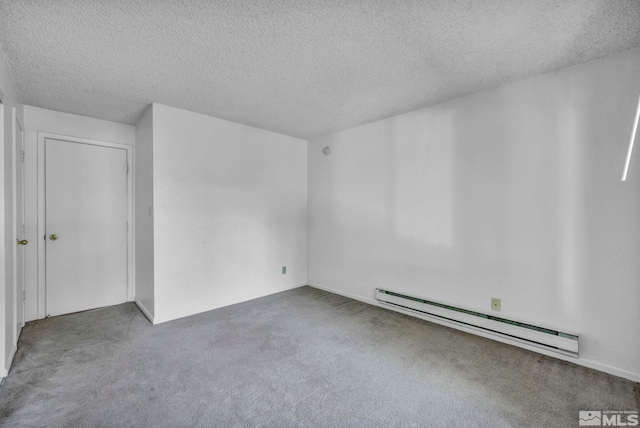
45, 138, 128, 316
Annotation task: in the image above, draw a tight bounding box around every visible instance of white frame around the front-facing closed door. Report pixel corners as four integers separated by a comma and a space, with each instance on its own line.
37, 132, 135, 319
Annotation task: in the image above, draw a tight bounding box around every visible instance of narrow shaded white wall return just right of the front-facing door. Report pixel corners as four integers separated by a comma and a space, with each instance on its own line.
134, 106, 154, 321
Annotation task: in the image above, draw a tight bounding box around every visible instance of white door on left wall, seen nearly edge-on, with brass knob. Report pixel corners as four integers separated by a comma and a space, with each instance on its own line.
14, 118, 27, 339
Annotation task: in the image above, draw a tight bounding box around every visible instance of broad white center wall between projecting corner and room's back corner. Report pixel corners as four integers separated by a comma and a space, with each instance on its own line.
153, 104, 307, 323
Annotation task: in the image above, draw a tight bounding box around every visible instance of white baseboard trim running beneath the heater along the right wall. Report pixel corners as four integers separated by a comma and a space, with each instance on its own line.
307, 283, 640, 382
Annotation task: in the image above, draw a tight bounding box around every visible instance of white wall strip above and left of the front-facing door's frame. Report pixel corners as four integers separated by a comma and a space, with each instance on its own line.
24, 106, 136, 321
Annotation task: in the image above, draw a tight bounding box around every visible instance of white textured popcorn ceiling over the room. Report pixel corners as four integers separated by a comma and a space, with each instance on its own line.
0, 0, 640, 138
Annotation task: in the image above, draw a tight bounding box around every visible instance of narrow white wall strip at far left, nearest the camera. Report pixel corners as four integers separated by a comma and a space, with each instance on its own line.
0, 42, 24, 378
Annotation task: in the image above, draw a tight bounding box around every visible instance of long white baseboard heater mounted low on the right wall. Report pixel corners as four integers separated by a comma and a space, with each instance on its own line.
376, 288, 578, 357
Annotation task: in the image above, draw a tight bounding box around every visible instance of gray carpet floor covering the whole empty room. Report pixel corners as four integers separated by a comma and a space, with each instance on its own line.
0, 287, 640, 427
